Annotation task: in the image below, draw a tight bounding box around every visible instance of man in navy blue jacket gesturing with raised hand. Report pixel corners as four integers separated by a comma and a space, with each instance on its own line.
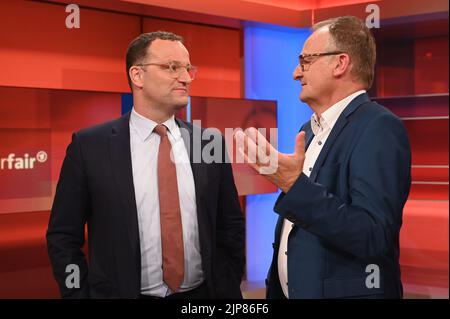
236, 17, 411, 298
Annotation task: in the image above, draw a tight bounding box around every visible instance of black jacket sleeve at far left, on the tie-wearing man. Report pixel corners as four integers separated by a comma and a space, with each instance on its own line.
47, 134, 90, 298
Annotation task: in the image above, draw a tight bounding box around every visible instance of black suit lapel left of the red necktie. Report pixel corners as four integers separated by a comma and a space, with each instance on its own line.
110, 113, 140, 264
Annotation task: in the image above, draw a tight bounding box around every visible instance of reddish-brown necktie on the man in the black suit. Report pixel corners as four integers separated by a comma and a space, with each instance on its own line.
154, 124, 184, 292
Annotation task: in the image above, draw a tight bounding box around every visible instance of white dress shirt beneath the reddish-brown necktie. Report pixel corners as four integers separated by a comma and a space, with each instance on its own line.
130, 108, 204, 297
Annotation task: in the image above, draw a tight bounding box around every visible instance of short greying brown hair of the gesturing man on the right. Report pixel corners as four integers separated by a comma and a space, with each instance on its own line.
313, 16, 376, 90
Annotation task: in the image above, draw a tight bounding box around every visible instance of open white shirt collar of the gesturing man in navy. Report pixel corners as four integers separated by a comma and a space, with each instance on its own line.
311, 90, 366, 135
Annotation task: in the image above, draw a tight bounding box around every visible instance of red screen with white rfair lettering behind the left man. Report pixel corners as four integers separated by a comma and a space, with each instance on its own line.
0, 87, 121, 214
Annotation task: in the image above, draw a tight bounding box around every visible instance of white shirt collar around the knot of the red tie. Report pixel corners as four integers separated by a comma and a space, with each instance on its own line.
130, 107, 181, 141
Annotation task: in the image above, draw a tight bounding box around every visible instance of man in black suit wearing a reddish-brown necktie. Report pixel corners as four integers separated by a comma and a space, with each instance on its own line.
47, 32, 245, 299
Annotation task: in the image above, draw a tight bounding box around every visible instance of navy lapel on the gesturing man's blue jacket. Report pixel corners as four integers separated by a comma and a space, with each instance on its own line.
309, 93, 370, 181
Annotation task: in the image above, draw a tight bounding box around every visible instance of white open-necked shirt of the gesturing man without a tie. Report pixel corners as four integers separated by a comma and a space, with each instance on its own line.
278, 90, 366, 298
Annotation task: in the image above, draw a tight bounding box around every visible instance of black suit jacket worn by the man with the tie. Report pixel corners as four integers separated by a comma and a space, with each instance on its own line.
47, 113, 245, 298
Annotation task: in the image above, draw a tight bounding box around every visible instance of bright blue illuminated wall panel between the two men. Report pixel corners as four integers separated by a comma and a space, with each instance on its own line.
244, 24, 312, 282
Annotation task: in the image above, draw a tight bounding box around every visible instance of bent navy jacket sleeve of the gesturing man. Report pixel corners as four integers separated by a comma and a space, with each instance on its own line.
275, 114, 411, 258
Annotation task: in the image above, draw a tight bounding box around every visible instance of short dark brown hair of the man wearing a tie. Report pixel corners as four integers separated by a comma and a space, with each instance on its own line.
125, 31, 183, 89
